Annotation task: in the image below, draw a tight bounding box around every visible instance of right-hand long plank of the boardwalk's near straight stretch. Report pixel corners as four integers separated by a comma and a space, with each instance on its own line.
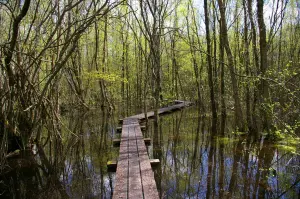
136, 126, 159, 199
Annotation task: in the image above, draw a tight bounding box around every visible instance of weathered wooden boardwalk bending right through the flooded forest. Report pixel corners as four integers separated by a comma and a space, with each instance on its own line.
113, 101, 191, 199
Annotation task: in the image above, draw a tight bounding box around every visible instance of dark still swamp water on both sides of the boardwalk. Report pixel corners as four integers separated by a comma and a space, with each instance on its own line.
0, 107, 300, 199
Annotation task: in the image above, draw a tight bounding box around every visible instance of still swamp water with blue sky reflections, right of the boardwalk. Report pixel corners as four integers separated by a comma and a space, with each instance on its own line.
149, 108, 300, 199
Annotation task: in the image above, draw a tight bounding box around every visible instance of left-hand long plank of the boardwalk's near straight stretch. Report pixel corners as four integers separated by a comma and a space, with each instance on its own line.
113, 125, 128, 199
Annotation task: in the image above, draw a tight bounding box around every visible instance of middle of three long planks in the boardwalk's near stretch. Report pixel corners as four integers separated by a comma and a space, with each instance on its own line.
128, 121, 143, 199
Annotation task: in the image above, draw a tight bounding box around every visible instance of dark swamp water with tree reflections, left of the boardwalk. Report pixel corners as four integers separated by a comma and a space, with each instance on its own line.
0, 109, 112, 198
